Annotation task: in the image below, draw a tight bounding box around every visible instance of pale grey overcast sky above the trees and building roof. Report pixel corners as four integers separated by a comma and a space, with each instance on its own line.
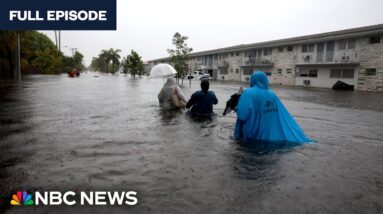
43, 0, 383, 65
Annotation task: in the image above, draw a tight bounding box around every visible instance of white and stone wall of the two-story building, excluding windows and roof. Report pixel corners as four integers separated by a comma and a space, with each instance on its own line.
150, 29, 383, 91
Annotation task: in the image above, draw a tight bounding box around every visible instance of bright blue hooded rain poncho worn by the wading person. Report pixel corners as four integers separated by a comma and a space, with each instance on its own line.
234, 71, 313, 143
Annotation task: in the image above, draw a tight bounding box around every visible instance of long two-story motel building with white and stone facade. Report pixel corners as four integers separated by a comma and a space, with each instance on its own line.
149, 24, 383, 91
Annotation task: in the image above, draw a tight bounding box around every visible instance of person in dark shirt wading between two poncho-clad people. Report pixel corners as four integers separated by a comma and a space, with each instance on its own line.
186, 80, 218, 117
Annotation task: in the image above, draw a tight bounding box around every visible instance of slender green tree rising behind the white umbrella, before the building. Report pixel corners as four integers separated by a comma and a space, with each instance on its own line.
167, 32, 193, 83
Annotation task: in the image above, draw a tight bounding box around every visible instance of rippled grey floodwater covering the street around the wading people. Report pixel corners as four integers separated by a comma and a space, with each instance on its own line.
0, 73, 383, 214
